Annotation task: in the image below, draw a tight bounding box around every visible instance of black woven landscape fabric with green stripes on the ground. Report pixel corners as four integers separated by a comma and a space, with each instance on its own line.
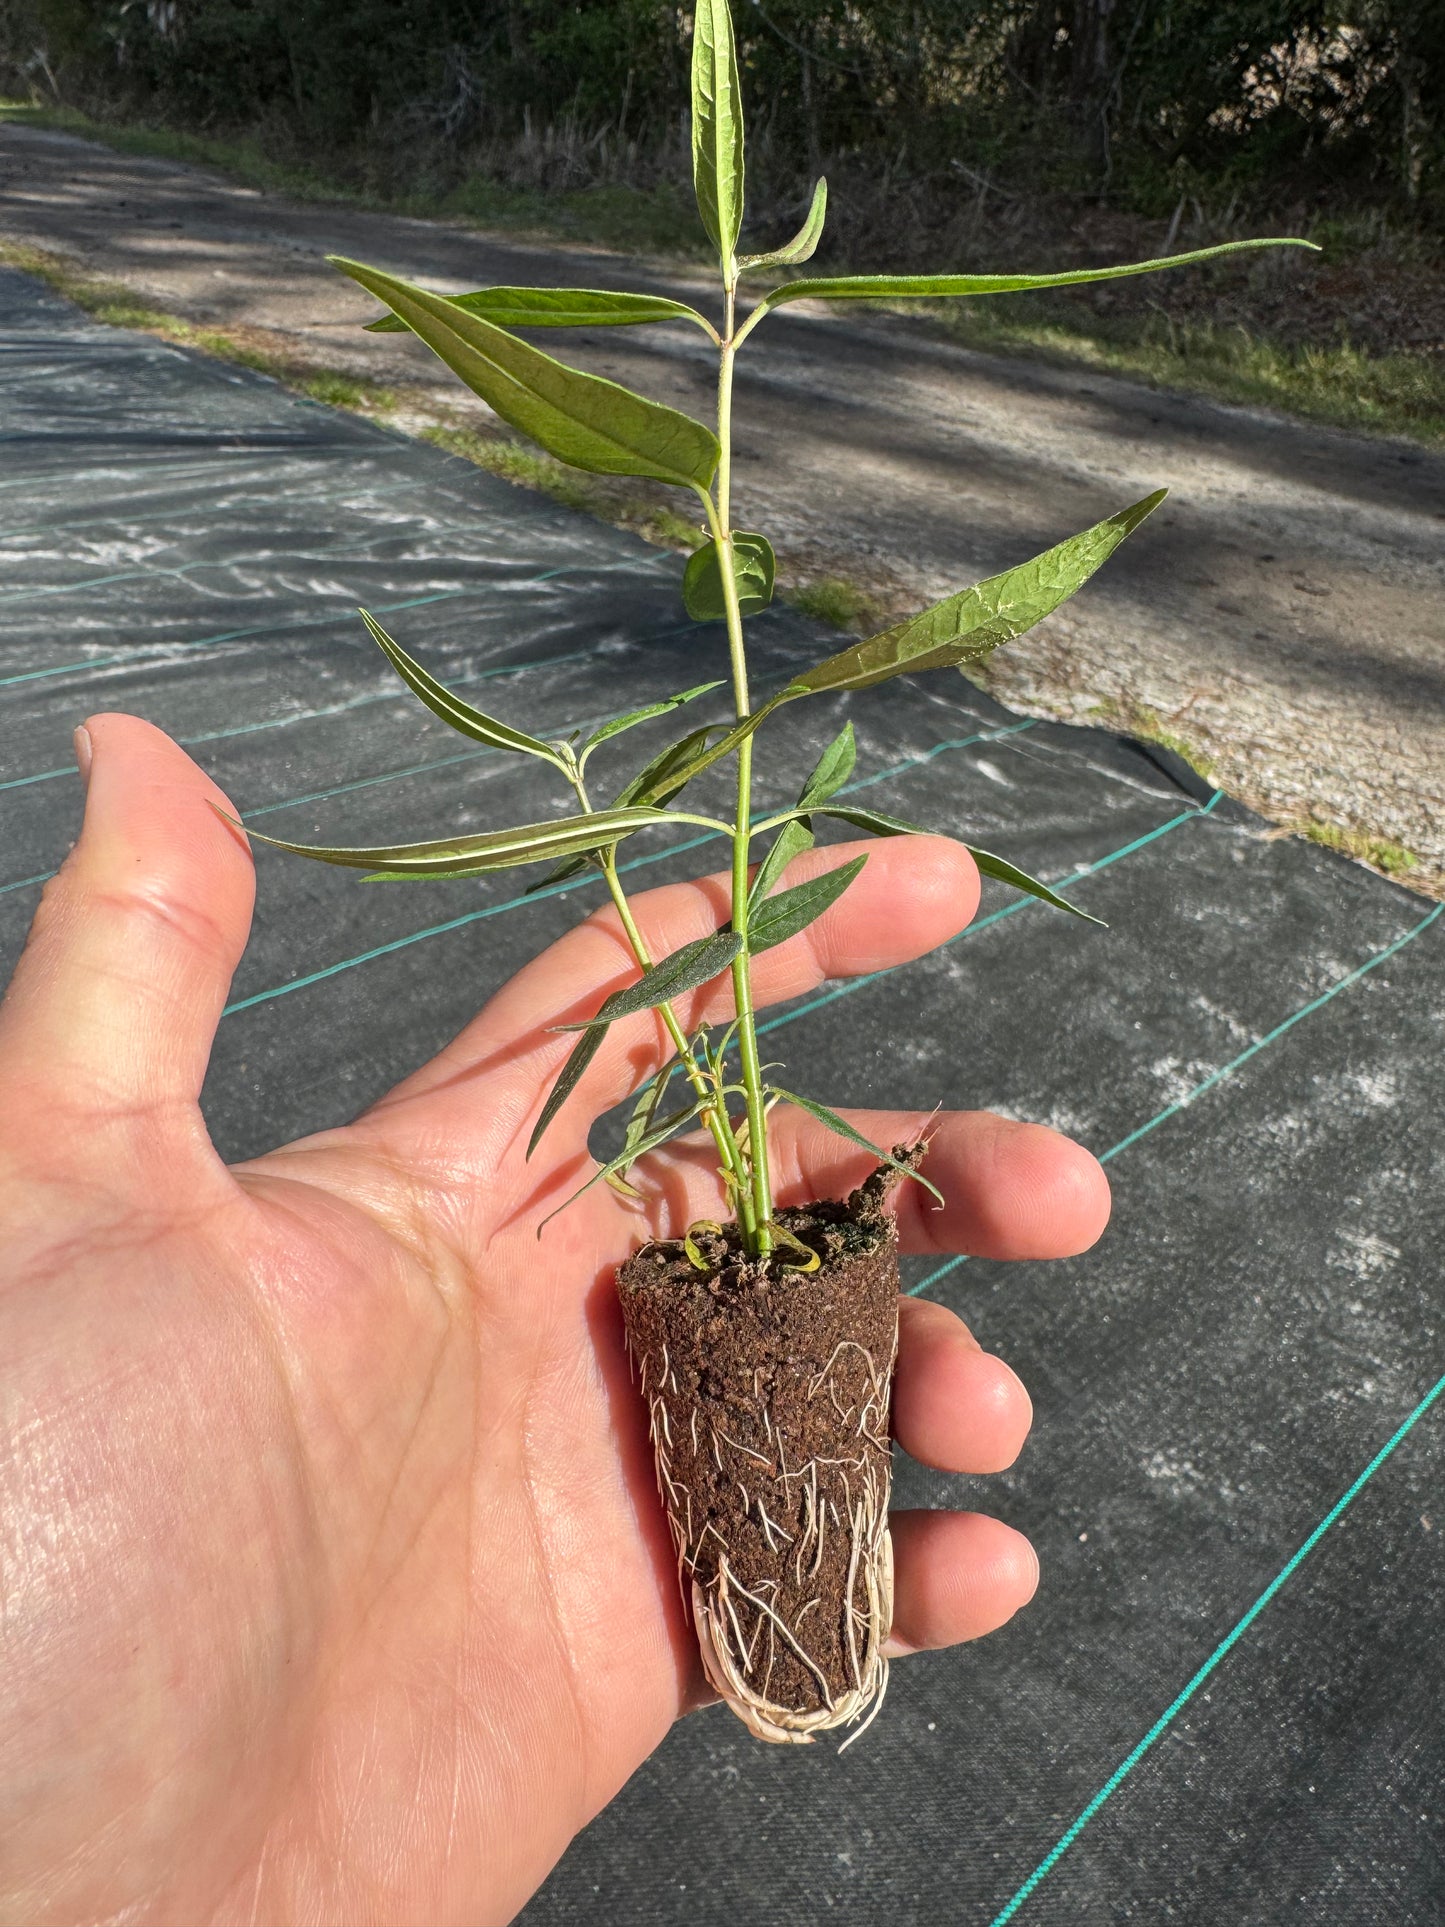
0, 272, 1445, 1927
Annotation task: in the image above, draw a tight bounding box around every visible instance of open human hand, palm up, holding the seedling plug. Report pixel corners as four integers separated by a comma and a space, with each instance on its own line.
0, 715, 1108, 1927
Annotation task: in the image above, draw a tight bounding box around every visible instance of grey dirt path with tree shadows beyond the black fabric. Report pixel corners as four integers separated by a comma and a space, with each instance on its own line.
0, 127, 1445, 896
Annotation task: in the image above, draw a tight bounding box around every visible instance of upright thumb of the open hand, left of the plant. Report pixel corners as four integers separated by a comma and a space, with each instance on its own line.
0, 715, 254, 1122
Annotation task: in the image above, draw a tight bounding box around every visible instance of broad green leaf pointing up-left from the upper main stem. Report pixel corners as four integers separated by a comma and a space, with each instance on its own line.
329, 254, 719, 488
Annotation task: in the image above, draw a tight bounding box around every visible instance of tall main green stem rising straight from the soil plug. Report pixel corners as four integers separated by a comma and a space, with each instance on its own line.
703, 287, 773, 1256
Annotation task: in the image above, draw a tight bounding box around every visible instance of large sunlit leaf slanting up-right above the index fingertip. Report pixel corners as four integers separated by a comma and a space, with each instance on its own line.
775, 489, 1168, 701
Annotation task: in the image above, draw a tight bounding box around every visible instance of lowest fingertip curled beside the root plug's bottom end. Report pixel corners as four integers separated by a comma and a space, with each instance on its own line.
888, 1513, 1038, 1655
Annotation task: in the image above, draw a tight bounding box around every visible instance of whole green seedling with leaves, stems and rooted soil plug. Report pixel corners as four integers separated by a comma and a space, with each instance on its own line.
246, 0, 1308, 1742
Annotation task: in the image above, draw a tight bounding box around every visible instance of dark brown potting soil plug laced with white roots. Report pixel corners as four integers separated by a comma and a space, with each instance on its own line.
618, 1170, 898, 1713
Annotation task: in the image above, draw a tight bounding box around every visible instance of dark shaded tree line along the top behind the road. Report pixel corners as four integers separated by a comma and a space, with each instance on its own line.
0, 0, 1445, 218
